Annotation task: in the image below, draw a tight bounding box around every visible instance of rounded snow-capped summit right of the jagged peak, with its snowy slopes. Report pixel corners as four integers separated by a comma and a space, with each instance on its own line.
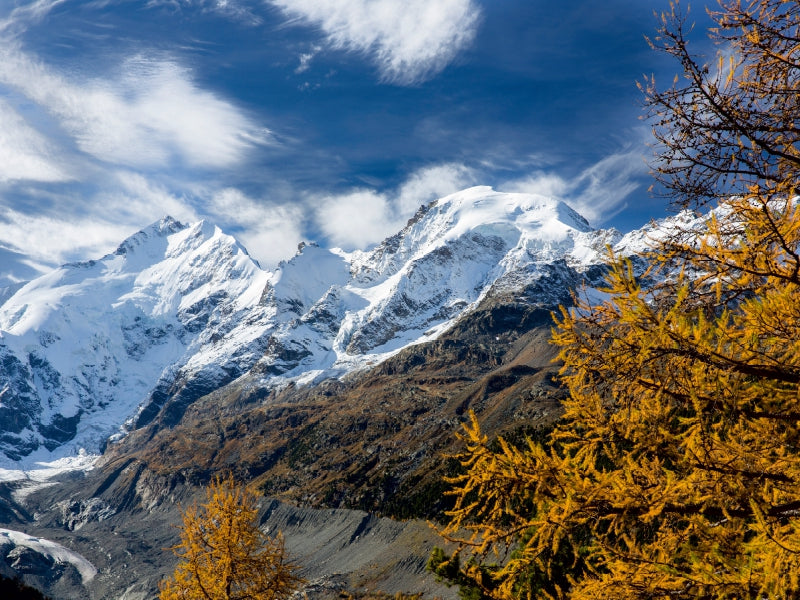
253, 187, 609, 379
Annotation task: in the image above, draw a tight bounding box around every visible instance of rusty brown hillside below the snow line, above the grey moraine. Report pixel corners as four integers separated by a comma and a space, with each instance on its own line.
104, 302, 561, 517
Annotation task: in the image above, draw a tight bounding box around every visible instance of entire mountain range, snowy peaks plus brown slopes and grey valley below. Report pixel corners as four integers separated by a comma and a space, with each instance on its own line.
0, 188, 700, 600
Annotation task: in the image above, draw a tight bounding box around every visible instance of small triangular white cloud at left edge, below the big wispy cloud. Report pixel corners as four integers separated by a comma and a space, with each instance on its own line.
0, 99, 71, 182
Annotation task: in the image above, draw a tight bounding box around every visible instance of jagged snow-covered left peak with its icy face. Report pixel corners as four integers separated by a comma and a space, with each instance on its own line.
0, 219, 268, 466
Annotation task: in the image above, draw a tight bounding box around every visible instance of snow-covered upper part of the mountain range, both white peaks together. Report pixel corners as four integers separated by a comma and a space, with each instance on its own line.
0, 187, 636, 466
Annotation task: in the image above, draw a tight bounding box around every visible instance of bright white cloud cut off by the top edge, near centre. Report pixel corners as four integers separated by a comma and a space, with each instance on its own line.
269, 0, 480, 84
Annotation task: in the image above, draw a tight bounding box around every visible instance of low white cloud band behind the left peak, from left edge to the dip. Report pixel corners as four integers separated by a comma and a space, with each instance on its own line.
0, 171, 304, 270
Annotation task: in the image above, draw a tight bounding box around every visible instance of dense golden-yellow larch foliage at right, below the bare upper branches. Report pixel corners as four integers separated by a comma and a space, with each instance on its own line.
444, 198, 800, 599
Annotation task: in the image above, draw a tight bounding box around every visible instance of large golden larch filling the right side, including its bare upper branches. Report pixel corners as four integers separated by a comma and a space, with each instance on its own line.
433, 0, 800, 600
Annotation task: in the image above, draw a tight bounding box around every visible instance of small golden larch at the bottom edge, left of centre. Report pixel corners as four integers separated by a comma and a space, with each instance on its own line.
159, 477, 303, 600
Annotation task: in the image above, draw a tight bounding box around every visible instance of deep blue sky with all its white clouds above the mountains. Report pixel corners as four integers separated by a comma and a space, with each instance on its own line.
0, 0, 703, 278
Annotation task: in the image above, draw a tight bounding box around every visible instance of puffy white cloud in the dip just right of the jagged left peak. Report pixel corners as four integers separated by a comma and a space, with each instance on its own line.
205, 188, 303, 268
